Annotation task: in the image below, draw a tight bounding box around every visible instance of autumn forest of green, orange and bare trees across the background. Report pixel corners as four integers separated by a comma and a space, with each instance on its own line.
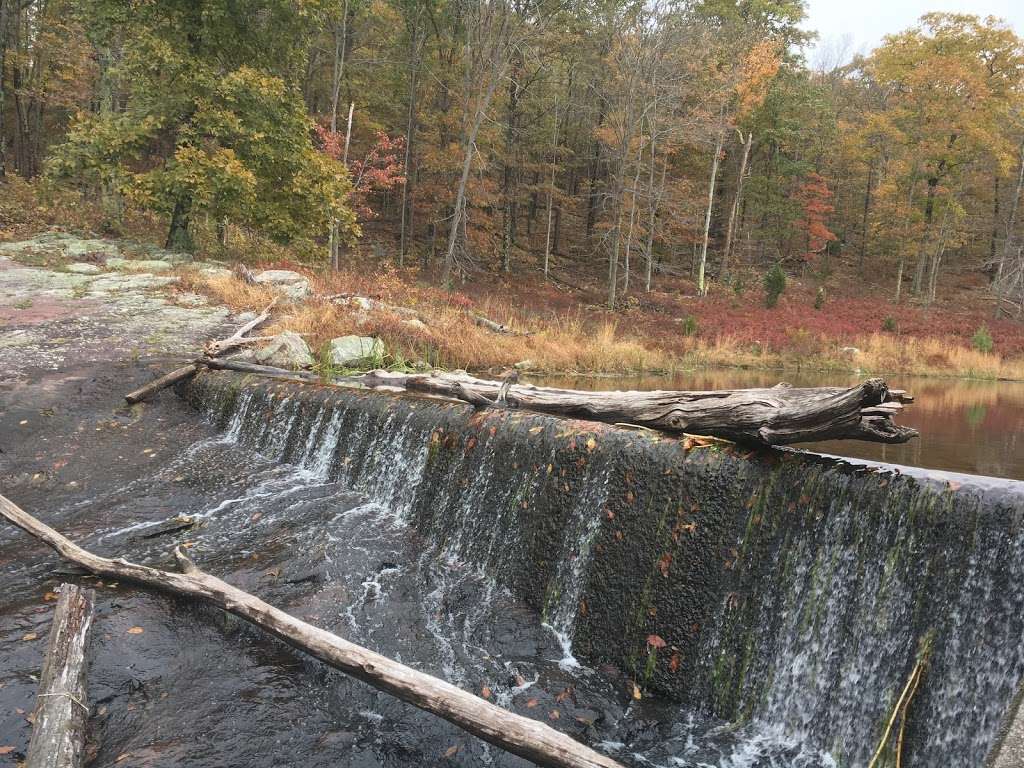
0, 0, 1024, 376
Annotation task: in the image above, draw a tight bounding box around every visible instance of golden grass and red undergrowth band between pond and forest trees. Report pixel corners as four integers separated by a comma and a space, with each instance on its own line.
0, 177, 1024, 381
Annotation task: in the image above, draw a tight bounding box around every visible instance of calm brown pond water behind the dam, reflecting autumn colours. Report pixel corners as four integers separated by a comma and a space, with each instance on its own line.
531, 370, 1024, 480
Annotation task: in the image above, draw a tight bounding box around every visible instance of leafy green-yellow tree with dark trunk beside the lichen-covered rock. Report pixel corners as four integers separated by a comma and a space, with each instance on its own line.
49, 0, 356, 250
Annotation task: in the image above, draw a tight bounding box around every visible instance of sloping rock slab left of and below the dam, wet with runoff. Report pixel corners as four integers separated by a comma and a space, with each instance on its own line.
0, 234, 823, 768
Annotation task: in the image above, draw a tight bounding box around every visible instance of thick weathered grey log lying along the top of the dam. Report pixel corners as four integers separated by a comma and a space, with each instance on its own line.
348, 371, 918, 445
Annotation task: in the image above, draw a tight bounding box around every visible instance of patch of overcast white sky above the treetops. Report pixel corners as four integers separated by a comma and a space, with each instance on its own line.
804, 0, 1024, 66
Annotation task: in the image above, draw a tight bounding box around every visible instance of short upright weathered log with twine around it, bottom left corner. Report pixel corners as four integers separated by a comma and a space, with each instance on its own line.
25, 581, 93, 768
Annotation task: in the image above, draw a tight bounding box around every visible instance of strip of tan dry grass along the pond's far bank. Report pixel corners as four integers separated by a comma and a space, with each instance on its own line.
174, 270, 1024, 380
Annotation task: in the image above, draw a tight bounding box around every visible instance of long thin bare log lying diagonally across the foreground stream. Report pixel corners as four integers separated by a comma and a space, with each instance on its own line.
0, 496, 623, 768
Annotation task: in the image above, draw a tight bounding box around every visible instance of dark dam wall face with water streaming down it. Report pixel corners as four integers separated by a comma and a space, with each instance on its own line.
185, 374, 1024, 768
